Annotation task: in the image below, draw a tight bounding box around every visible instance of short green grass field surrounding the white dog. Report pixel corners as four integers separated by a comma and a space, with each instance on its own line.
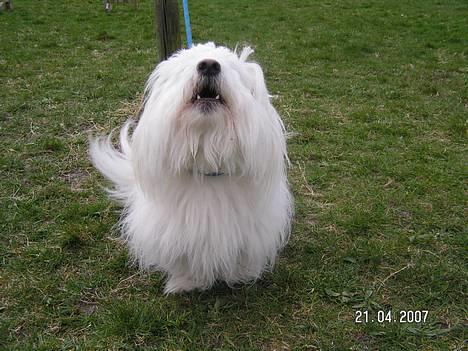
0, 0, 468, 350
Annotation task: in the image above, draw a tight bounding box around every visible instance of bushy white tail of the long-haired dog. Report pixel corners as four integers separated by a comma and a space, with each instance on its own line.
89, 120, 135, 202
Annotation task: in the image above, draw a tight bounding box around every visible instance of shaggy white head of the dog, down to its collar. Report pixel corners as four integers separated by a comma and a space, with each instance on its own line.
133, 43, 285, 187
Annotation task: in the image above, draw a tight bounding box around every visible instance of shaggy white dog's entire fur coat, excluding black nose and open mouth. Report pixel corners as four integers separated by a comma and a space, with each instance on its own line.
90, 43, 292, 293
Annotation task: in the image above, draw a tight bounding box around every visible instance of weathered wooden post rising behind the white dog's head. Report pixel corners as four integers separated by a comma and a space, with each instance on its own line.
155, 0, 181, 61
